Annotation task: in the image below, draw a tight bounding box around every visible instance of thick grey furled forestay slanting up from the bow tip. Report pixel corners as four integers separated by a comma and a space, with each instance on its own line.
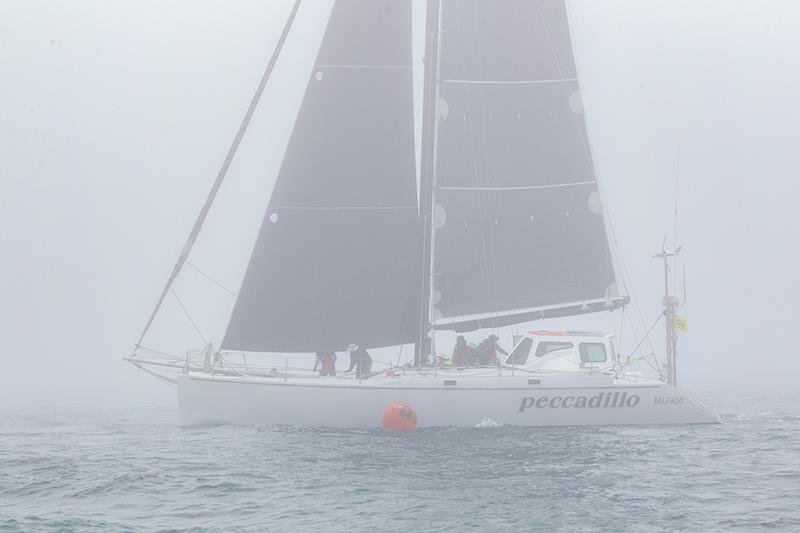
133, 0, 302, 355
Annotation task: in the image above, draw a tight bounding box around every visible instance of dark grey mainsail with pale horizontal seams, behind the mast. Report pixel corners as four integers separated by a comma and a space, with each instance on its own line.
432, 0, 627, 330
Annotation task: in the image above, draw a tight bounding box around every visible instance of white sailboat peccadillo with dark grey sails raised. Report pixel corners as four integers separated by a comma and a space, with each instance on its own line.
127, 0, 719, 427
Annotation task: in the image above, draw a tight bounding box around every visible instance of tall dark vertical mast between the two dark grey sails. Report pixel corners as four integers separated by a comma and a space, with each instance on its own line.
414, 0, 441, 366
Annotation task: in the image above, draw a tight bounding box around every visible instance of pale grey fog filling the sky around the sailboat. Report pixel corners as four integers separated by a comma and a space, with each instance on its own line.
0, 0, 800, 405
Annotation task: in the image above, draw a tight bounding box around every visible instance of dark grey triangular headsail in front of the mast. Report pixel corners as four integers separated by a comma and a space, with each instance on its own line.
222, 0, 421, 352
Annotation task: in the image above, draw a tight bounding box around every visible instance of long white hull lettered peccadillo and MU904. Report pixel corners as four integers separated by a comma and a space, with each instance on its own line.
177, 370, 720, 428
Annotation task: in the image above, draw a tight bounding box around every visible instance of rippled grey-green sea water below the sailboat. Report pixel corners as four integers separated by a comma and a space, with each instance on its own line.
0, 389, 800, 532
